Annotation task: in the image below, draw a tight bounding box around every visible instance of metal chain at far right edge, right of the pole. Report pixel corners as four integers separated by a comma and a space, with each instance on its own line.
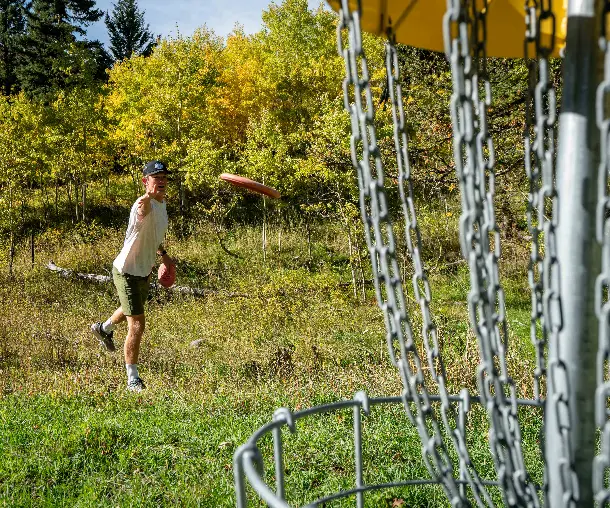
593, 0, 610, 506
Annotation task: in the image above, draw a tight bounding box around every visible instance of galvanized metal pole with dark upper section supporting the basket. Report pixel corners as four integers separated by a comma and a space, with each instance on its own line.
545, 0, 600, 507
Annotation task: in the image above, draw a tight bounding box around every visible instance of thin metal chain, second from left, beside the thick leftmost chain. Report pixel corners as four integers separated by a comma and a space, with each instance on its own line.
386, 33, 494, 506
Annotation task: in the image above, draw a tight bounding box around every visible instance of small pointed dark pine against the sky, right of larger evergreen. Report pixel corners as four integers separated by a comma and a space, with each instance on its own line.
106, 0, 154, 60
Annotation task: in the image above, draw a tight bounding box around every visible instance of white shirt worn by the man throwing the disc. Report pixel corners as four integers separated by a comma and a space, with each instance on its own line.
112, 198, 167, 277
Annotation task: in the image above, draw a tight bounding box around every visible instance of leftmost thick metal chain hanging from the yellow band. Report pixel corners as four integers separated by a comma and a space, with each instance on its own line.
337, 0, 470, 506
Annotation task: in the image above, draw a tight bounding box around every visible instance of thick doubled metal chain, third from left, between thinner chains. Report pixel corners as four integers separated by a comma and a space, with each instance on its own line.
443, 0, 540, 506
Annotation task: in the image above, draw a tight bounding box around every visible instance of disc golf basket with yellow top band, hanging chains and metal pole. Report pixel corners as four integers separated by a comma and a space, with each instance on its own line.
234, 0, 610, 508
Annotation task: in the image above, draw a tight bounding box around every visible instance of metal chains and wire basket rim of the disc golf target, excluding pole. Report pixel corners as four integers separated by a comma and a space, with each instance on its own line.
230, 0, 580, 507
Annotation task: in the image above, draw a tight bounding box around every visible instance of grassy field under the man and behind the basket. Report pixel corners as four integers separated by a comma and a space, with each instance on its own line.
0, 193, 541, 506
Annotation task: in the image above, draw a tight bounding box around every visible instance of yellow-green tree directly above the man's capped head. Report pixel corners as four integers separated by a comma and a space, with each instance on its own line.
107, 29, 222, 170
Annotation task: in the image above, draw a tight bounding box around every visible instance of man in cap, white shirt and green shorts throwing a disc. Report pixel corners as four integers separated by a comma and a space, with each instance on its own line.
91, 161, 174, 392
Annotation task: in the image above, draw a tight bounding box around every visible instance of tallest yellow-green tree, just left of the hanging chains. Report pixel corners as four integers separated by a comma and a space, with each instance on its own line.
242, 0, 370, 215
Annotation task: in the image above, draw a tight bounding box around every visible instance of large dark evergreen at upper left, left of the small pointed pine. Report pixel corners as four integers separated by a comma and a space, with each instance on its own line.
17, 0, 103, 98
